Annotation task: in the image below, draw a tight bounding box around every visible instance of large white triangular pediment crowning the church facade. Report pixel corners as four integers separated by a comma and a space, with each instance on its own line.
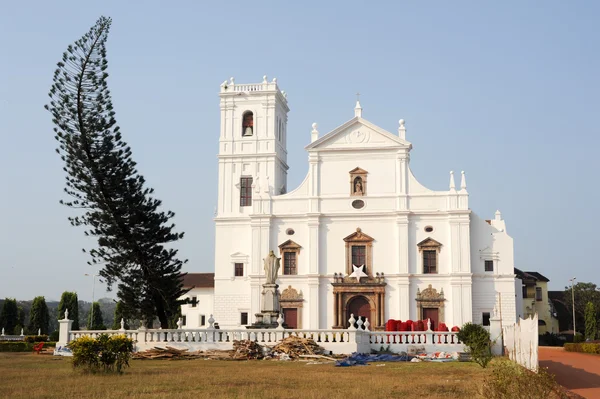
306, 117, 411, 151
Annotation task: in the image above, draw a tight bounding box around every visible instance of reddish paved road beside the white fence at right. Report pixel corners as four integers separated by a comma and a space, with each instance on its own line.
539, 346, 600, 399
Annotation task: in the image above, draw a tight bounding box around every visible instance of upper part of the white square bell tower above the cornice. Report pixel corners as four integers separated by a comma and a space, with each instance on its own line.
217, 76, 289, 217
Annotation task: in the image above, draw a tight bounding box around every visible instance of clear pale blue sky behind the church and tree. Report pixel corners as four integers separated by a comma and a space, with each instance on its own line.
0, 1, 600, 300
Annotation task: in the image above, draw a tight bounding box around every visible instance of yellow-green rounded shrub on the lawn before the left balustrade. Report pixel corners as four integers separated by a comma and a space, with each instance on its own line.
68, 334, 133, 373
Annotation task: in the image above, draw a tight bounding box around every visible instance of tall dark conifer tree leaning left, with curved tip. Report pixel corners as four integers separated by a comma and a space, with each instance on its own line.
46, 17, 187, 328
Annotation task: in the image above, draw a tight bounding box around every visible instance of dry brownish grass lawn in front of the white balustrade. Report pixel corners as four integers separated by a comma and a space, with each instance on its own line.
0, 353, 489, 399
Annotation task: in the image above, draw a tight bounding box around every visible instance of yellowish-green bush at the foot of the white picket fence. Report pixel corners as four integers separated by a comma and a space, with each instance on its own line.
479, 359, 568, 399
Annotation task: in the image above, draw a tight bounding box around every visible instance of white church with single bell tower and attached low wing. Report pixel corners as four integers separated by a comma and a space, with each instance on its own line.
182, 77, 518, 330
